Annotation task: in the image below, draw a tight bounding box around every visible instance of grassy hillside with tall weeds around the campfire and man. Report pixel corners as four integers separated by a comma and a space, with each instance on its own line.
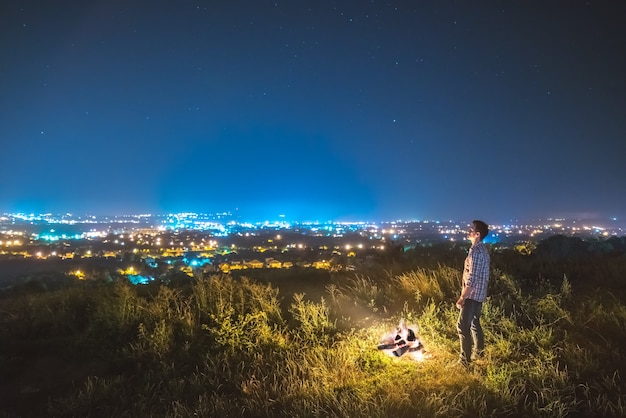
0, 237, 626, 417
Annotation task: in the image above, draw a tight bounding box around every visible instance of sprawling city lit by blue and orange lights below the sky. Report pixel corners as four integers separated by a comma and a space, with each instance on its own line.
0, 212, 626, 282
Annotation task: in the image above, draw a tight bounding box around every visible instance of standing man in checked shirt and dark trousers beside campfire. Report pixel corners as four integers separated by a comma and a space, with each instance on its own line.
456, 221, 490, 366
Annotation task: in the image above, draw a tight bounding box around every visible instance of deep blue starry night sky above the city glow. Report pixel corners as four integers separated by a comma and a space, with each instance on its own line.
0, 0, 626, 223
